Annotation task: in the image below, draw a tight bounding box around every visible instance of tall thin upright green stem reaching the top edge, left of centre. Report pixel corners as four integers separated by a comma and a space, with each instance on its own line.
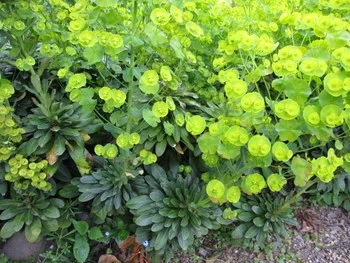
126, 0, 137, 132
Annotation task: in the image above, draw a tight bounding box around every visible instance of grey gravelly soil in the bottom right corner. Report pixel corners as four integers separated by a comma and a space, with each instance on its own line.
173, 207, 350, 263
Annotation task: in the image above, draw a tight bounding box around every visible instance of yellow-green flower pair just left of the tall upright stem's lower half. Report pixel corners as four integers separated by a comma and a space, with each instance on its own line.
98, 87, 126, 112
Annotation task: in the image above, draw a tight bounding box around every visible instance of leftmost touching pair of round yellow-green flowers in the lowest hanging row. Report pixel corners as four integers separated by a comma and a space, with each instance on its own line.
206, 179, 241, 204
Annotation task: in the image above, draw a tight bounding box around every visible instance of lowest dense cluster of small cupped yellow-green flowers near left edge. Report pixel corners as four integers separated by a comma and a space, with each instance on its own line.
5, 154, 52, 191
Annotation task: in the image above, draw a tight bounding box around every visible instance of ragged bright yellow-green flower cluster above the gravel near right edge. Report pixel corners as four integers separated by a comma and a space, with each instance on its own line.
311, 148, 343, 183
